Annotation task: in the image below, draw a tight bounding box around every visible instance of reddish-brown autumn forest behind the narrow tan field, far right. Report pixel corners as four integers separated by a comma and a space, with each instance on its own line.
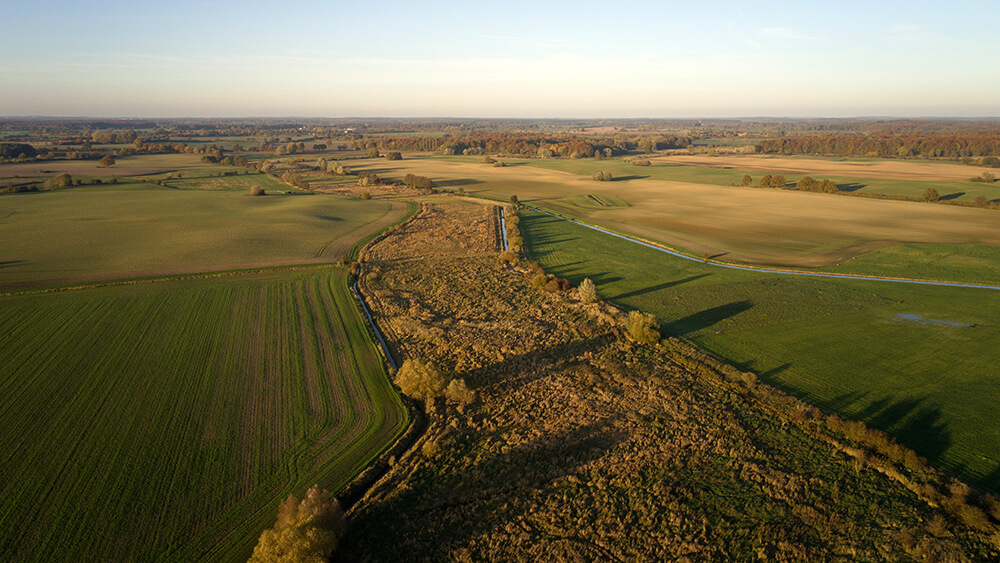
756, 136, 1000, 165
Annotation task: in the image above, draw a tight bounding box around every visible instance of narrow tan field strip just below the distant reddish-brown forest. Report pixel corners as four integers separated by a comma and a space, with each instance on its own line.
650, 154, 995, 181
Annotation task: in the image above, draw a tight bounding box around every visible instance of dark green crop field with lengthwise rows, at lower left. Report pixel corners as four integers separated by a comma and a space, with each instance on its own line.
0, 267, 408, 561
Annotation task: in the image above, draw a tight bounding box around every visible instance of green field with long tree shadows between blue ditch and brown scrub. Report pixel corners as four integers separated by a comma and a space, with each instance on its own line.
521, 210, 1000, 491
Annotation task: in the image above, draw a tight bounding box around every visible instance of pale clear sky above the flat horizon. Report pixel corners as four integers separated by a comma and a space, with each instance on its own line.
0, 0, 1000, 118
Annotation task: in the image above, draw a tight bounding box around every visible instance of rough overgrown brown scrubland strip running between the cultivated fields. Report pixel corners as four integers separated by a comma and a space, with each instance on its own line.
339, 200, 997, 561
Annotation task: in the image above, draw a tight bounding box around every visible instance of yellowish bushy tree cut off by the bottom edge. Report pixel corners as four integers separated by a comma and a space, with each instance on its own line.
250, 485, 345, 563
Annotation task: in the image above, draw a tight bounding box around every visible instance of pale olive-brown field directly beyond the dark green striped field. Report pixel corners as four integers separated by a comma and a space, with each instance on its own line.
0, 185, 406, 289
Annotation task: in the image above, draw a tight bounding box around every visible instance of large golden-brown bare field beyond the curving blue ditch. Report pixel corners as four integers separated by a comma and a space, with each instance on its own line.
332, 157, 1000, 266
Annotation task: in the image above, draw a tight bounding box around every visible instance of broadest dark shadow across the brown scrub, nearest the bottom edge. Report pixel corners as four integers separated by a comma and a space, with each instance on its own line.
344, 422, 625, 561
